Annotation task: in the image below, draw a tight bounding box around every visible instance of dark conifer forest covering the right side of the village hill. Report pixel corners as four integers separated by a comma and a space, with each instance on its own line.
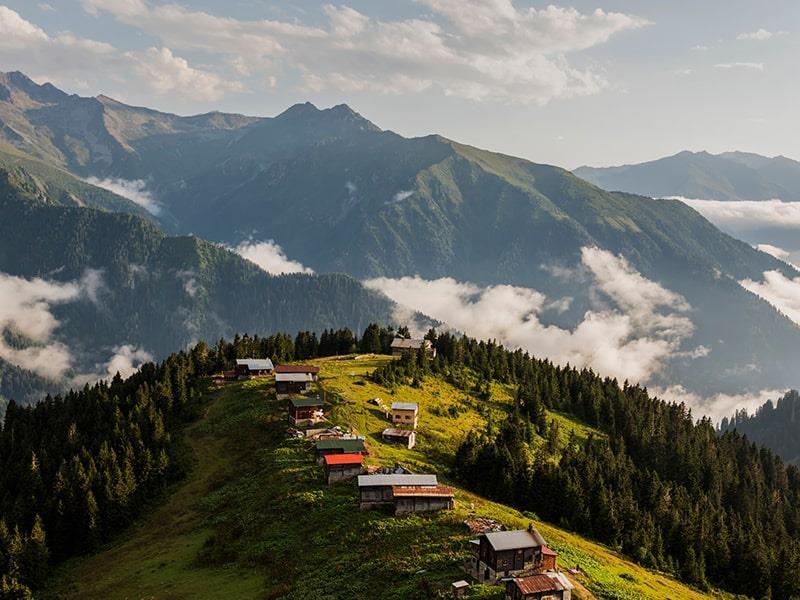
372, 332, 800, 599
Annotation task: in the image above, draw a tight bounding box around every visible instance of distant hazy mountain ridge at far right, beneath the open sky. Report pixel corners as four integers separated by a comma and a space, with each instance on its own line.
573, 151, 800, 201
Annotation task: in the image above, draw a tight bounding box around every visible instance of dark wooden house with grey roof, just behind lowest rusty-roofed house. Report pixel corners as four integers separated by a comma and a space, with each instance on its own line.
467, 526, 554, 583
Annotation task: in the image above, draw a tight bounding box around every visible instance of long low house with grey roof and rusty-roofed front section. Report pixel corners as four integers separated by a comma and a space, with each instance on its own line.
358, 473, 453, 515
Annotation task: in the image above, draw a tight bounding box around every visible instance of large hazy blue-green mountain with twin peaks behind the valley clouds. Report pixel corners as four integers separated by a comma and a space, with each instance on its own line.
0, 74, 800, 393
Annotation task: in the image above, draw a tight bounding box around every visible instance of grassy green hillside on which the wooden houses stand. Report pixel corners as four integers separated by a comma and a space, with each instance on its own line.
51, 356, 720, 599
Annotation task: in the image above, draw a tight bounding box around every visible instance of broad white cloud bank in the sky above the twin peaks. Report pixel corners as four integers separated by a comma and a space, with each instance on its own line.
78, 0, 649, 104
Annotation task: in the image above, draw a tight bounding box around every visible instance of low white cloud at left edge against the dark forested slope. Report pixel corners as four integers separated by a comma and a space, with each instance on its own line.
0, 273, 81, 379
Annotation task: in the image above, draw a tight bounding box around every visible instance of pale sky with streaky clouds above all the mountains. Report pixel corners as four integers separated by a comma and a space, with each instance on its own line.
0, 0, 800, 168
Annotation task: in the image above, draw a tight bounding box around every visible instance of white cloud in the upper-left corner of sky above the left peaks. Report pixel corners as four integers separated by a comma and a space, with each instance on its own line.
0, 2, 243, 101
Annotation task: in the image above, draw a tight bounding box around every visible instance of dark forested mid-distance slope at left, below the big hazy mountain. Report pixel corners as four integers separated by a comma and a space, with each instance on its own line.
0, 170, 394, 400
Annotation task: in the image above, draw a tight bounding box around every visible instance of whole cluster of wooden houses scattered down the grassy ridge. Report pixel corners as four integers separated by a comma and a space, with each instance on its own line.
230, 356, 574, 600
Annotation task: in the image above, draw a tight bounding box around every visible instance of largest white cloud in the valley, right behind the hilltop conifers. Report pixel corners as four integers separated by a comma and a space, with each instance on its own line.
365, 248, 694, 381
